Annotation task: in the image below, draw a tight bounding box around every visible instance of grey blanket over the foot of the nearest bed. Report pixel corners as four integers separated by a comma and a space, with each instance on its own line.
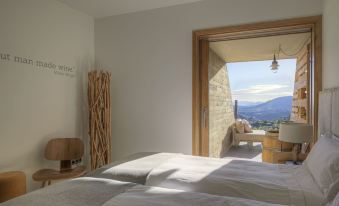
0, 177, 137, 206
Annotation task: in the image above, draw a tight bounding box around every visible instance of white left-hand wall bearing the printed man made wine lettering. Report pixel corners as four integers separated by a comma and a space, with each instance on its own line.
0, 0, 94, 189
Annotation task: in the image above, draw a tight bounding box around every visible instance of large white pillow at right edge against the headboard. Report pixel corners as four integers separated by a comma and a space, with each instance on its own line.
305, 135, 339, 201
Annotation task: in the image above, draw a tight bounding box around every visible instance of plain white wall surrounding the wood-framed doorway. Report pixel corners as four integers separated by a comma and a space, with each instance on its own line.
95, 0, 322, 159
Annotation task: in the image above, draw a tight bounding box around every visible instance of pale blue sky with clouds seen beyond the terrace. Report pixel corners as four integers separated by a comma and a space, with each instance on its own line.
227, 59, 296, 102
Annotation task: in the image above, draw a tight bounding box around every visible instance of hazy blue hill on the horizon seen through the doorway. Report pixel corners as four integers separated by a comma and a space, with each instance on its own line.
238, 96, 292, 122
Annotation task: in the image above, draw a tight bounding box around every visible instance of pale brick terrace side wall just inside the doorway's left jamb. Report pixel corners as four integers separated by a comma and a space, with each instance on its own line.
208, 49, 235, 157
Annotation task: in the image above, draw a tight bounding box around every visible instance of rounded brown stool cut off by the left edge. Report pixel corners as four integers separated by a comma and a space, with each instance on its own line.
0, 171, 26, 202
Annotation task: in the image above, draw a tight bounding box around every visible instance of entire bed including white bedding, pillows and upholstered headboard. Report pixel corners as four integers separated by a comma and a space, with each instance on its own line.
0, 90, 339, 206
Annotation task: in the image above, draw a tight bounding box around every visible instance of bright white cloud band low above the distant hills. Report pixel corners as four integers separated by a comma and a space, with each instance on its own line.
232, 84, 293, 102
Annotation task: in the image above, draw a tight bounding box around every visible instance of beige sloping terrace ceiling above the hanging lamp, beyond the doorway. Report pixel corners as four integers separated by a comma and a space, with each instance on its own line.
210, 33, 311, 62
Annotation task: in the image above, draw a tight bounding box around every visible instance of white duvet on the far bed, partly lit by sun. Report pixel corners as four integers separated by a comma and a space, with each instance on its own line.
146, 155, 326, 206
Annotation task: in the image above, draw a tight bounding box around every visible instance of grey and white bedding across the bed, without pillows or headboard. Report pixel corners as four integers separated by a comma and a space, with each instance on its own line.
0, 153, 326, 206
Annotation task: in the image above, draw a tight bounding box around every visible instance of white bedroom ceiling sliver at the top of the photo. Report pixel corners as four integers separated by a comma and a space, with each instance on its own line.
58, 0, 205, 18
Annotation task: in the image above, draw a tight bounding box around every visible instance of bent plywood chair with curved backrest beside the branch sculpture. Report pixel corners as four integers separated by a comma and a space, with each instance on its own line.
32, 138, 86, 187
